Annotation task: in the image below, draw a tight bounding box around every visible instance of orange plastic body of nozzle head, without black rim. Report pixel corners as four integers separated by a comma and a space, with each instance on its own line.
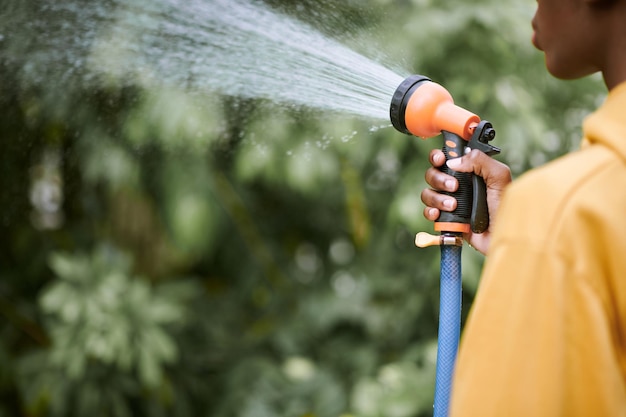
404, 82, 480, 140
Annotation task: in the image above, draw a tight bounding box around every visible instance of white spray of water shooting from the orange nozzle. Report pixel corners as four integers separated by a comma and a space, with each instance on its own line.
0, 0, 404, 120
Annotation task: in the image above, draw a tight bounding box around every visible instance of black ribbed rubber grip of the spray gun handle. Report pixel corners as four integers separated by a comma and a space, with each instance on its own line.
435, 130, 470, 224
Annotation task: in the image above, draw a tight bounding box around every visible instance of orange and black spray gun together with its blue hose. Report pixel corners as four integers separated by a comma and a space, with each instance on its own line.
389, 75, 500, 417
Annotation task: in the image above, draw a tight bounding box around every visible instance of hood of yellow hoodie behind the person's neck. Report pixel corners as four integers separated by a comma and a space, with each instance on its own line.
583, 82, 626, 162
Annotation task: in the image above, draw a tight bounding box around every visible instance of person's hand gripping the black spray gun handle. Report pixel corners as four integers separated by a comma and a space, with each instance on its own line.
422, 149, 512, 255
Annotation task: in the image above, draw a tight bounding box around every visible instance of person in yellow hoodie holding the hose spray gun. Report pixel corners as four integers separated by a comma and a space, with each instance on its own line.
421, 0, 626, 417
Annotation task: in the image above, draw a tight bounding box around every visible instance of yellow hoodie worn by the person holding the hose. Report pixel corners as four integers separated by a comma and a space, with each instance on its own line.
450, 84, 626, 417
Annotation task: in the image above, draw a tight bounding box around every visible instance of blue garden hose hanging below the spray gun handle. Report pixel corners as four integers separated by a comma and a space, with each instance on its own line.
434, 245, 462, 417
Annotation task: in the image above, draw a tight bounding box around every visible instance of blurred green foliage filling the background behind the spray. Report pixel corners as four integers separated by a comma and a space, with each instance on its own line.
0, 0, 602, 417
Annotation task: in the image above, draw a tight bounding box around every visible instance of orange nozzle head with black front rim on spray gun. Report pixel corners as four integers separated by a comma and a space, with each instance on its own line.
389, 75, 480, 140
